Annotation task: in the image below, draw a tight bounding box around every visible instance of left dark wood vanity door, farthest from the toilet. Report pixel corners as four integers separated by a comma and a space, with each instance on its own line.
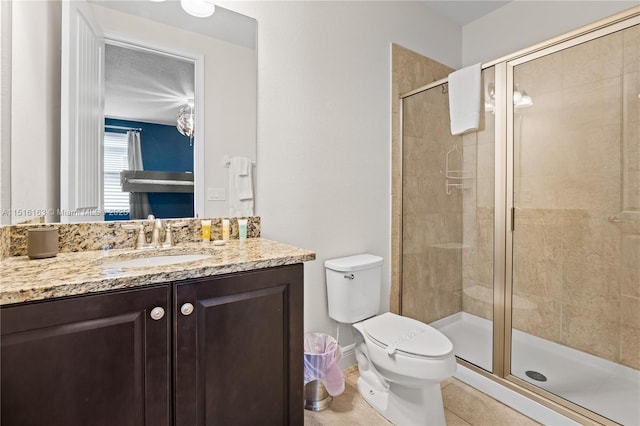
0, 285, 172, 426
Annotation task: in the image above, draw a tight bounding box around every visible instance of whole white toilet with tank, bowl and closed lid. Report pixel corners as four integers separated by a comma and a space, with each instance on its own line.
325, 254, 456, 425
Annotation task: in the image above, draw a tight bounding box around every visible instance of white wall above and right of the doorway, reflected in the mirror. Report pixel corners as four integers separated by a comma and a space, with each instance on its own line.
92, 4, 257, 217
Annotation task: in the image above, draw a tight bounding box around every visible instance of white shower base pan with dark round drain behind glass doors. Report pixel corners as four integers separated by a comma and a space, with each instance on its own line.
431, 312, 640, 425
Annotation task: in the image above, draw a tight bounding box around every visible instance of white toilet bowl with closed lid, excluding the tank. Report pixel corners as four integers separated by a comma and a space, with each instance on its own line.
353, 312, 456, 425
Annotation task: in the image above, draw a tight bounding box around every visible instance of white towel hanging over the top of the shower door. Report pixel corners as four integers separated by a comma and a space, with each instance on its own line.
449, 64, 482, 135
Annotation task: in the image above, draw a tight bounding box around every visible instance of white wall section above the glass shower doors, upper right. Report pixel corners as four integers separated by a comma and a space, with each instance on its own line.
462, 0, 640, 65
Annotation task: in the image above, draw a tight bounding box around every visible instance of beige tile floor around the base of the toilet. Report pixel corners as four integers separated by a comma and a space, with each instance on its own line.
304, 367, 539, 426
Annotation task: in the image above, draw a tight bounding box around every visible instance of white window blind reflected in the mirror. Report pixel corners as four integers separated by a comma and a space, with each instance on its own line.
104, 131, 129, 213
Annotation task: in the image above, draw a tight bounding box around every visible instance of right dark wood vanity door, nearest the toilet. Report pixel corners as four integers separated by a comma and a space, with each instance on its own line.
174, 264, 304, 426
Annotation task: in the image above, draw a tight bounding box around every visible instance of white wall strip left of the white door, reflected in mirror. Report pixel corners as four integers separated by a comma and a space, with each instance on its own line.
11, 1, 61, 223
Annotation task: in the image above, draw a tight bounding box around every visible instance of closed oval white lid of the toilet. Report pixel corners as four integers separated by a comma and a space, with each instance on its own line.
363, 312, 453, 357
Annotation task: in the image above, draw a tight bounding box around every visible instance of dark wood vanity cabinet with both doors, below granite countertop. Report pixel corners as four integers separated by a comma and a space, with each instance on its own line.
0, 264, 304, 426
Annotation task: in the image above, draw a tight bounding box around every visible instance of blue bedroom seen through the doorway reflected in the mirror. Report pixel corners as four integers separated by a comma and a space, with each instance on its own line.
103, 41, 195, 221
